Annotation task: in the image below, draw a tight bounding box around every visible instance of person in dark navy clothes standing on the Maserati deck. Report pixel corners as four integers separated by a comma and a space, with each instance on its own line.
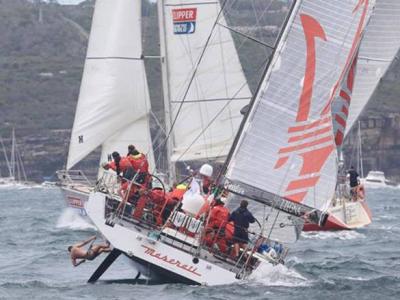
229, 200, 256, 257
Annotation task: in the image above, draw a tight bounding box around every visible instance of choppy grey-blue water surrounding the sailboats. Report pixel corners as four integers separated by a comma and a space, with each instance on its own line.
0, 187, 400, 300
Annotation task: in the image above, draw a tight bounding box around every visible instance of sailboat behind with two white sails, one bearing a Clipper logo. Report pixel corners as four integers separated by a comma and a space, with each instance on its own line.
58, 0, 251, 216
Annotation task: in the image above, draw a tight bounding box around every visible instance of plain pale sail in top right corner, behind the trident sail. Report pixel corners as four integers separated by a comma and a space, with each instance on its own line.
342, 0, 400, 135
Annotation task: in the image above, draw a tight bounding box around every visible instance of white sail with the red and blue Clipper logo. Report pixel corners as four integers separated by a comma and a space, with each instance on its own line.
159, 0, 251, 161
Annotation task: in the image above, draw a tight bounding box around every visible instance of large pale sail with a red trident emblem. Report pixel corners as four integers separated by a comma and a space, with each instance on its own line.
225, 0, 374, 241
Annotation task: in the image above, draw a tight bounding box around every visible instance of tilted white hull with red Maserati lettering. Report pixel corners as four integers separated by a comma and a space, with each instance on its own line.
86, 192, 239, 286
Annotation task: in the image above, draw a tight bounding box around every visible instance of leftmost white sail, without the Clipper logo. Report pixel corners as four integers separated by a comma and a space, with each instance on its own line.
67, 0, 154, 169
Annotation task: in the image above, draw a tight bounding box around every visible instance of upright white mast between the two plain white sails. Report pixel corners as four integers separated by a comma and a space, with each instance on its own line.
157, 0, 176, 185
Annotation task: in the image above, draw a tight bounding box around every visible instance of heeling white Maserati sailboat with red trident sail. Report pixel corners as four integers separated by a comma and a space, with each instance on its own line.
86, 0, 374, 285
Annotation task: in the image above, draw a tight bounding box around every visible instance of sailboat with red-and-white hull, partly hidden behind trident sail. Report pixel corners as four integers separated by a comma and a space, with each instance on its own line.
304, 0, 400, 231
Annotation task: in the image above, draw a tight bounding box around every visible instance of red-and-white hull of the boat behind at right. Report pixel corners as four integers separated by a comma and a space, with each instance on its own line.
303, 200, 372, 231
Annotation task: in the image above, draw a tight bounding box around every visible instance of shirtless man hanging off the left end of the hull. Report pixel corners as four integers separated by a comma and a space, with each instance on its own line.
68, 236, 111, 267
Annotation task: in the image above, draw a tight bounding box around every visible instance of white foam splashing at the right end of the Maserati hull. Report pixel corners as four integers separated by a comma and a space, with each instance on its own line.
249, 263, 311, 287
